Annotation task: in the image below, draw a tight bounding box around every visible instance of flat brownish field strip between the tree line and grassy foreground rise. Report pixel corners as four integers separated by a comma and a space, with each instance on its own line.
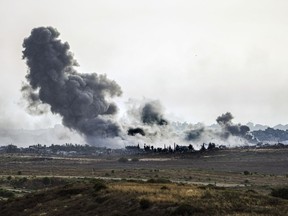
0, 149, 288, 186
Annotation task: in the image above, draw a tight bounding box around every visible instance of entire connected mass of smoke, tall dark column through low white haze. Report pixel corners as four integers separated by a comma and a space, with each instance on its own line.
22, 27, 253, 146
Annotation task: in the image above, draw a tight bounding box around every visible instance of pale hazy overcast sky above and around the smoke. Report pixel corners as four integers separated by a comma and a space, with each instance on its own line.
0, 0, 288, 129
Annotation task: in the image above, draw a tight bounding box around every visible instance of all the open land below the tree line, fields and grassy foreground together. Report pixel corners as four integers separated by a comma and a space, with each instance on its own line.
0, 149, 288, 215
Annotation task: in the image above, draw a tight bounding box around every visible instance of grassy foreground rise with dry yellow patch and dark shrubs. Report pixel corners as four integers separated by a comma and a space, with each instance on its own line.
0, 178, 288, 216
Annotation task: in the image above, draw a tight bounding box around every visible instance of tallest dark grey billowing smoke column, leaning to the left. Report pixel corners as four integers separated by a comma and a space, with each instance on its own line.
22, 27, 122, 138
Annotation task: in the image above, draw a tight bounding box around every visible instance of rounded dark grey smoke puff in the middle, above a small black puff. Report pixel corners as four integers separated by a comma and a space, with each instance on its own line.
141, 101, 168, 126
